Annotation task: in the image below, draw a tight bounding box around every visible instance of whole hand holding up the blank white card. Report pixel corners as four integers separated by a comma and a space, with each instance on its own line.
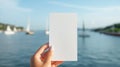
30, 43, 63, 67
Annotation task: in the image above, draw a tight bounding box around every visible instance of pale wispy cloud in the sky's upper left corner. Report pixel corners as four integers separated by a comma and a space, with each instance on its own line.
0, 0, 32, 12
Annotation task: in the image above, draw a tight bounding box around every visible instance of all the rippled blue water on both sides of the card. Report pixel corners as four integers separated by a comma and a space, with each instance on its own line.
0, 31, 120, 67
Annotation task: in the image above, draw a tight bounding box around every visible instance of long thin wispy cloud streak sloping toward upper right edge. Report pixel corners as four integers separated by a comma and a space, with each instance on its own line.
49, 1, 120, 12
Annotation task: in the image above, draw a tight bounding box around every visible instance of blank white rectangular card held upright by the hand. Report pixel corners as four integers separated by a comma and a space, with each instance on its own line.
49, 13, 77, 61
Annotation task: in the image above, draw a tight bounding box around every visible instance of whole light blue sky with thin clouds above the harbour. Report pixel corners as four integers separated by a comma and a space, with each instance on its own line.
0, 0, 120, 30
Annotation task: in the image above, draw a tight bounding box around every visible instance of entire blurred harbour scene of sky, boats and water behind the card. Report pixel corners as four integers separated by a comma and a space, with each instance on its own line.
0, 0, 120, 67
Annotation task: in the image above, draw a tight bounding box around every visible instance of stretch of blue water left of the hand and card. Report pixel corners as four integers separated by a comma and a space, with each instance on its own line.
0, 31, 48, 67
